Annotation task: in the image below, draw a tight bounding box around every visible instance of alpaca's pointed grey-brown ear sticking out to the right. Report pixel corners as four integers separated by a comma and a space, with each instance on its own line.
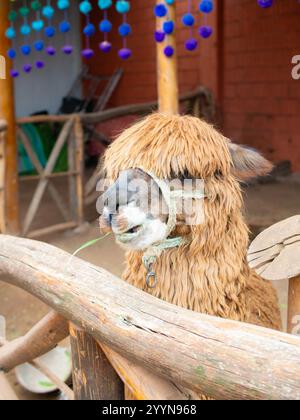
229, 142, 273, 181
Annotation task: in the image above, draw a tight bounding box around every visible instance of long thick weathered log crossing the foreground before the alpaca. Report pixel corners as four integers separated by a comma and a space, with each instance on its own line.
0, 235, 300, 400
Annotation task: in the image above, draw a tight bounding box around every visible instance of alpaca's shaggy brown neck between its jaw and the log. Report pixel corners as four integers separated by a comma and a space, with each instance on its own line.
124, 213, 249, 320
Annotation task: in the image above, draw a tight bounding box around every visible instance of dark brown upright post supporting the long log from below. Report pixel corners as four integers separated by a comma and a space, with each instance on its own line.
70, 324, 124, 401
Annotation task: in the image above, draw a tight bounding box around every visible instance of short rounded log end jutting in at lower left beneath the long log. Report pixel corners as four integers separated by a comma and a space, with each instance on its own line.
0, 308, 69, 372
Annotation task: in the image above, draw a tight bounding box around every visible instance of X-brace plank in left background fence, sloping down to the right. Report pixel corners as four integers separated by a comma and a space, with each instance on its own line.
18, 128, 70, 221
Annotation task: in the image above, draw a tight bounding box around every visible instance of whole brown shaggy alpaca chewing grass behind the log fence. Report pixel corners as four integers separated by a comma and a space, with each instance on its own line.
100, 113, 281, 329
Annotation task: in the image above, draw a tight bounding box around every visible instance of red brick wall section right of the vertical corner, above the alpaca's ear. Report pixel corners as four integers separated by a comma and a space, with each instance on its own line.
222, 0, 300, 171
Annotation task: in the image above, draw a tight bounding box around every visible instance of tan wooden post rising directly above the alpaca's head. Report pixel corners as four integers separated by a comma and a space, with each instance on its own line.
156, 0, 179, 114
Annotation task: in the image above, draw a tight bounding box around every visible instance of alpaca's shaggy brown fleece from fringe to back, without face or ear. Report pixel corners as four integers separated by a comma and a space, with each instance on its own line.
104, 114, 281, 329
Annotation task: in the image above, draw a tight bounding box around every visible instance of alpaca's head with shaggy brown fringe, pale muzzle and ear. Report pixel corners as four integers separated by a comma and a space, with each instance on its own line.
100, 114, 272, 249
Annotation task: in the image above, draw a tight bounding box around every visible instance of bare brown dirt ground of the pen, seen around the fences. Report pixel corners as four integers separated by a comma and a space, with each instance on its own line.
0, 178, 300, 399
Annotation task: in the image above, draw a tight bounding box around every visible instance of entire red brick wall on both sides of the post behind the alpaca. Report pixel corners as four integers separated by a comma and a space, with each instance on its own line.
84, 0, 300, 171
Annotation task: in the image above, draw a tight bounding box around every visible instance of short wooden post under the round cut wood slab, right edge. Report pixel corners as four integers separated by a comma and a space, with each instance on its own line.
288, 276, 300, 335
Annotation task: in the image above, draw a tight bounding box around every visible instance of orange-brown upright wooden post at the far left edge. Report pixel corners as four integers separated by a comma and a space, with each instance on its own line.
0, 1, 19, 234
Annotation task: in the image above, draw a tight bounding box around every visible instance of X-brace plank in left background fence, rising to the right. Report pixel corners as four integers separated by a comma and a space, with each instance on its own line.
23, 119, 74, 235
